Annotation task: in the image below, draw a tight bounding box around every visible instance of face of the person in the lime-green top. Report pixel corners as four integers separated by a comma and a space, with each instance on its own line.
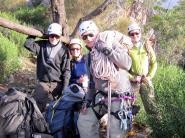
129, 30, 141, 44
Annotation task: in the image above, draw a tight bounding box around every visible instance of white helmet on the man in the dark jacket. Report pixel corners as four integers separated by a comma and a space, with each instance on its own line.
48, 23, 62, 36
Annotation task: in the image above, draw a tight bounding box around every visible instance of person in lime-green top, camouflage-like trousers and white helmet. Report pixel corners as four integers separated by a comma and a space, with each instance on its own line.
128, 23, 161, 124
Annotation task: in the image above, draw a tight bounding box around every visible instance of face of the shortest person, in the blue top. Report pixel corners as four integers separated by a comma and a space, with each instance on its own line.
70, 44, 81, 58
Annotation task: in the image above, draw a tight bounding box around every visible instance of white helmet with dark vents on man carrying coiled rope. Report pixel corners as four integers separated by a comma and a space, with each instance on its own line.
79, 20, 98, 36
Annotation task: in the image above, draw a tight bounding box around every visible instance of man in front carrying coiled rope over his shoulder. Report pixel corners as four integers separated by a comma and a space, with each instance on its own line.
77, 20, 132, 138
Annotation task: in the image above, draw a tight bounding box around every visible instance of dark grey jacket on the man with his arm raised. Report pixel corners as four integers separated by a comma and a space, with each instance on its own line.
24, 38, 70, 91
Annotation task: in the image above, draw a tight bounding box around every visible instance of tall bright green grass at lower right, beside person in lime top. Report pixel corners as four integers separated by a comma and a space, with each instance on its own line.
154, 64, 185, 137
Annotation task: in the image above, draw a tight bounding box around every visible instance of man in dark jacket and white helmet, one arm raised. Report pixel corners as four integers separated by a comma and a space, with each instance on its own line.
24, 23, 70, 112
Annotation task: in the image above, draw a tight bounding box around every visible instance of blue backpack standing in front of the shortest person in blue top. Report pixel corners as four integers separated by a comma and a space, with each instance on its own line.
45, 84, 85, 138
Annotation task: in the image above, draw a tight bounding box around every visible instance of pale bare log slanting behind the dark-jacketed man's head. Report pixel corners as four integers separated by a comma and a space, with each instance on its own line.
0, 17, 69, 44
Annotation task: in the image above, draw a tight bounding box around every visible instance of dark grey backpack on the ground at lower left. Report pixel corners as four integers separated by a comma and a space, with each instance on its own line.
0, 88, 49, 138
